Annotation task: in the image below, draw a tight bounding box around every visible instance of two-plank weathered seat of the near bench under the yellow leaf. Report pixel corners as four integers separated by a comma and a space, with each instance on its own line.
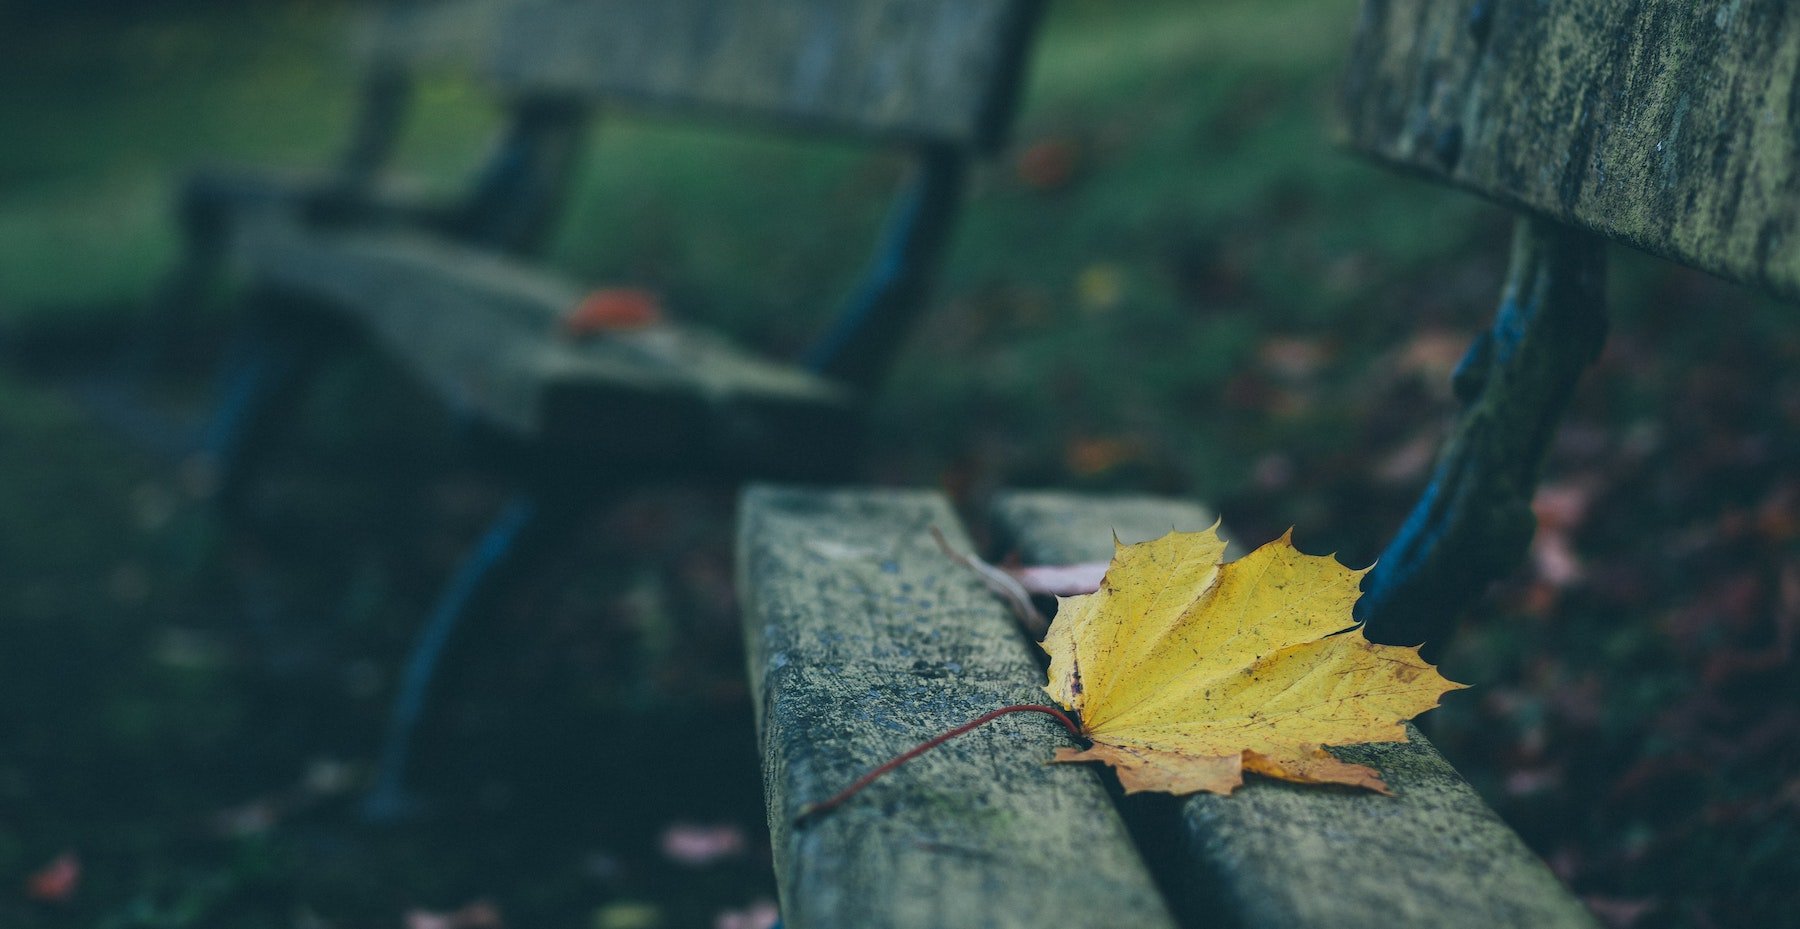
738, 486, 1595, 929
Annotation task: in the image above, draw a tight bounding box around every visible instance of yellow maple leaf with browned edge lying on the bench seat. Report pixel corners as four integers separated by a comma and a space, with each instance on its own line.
1044, 528, 1463, 794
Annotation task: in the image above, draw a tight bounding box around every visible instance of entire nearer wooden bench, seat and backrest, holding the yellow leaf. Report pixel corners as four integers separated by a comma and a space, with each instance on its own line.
740, 0, 1800, 929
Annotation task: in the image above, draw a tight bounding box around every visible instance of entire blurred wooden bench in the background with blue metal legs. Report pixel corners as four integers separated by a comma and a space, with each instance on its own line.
171, 0, 1040, 814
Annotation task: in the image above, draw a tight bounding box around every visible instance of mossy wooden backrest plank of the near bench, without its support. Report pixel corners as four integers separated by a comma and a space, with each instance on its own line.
1345, 0, 1800, 299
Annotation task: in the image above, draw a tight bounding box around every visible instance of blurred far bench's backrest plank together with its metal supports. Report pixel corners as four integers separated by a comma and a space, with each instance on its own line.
344, 0, 1044, 391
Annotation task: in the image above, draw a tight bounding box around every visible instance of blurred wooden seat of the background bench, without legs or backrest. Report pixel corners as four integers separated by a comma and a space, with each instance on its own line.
243, 223, 855, 474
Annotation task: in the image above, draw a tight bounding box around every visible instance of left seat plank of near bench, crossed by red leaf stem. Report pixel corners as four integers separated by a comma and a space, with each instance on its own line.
738, 486, 1172, 929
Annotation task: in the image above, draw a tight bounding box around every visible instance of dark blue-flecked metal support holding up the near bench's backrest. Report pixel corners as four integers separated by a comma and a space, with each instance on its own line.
1357, 218, 1606, 645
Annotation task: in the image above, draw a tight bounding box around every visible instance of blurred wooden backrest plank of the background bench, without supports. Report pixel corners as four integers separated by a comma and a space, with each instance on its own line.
493, 0, 1040, 144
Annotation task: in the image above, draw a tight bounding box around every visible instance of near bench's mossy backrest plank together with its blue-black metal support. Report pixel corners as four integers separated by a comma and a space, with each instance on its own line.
1343, 0, 1800, 643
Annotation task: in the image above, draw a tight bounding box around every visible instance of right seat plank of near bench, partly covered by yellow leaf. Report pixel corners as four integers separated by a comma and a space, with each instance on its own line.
994, 493, 1595, 929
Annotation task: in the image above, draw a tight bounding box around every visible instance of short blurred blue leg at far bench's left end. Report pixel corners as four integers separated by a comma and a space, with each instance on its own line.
203, 298, 328, 515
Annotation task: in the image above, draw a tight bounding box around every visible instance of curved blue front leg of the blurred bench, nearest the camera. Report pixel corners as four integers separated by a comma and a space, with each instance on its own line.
362, 493, 585, 823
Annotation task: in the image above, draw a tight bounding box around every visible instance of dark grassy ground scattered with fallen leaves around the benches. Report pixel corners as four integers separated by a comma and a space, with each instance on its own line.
0, 0, 1800, 929
